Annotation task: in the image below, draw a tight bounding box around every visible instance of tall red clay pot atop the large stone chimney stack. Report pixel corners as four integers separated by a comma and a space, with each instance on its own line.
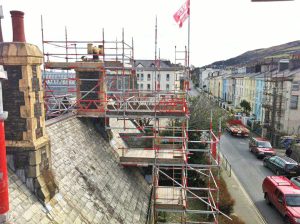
10, 11, 26, 42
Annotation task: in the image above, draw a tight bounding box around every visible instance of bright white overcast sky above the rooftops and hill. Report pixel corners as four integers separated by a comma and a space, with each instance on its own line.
0, 0, 300, 66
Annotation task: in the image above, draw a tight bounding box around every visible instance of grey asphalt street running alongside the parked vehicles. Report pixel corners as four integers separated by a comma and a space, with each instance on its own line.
220, 133, 284, 224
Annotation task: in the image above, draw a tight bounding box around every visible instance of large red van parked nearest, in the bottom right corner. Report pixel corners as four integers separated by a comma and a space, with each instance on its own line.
262, 176, 300, 224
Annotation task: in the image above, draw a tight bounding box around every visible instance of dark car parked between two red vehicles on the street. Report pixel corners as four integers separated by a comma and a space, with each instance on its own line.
263, 156, 300, 177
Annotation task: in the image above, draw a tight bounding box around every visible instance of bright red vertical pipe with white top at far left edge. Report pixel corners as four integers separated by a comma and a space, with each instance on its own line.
0, 65, 9, 222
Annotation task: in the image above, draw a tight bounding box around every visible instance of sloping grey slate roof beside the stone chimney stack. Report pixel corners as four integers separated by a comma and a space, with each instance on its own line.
5, 117, 150, 224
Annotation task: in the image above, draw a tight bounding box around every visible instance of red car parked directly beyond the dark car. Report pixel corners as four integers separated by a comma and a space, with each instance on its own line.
249, 137, 276, 158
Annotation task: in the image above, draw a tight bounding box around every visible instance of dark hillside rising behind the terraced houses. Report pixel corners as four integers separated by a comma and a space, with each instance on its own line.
206, 40, 300, 67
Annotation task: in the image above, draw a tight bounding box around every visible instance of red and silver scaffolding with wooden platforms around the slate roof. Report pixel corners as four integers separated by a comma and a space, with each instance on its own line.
42, 21, 221, 223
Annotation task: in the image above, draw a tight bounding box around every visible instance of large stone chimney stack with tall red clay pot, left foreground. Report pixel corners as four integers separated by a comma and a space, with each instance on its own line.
0, 11, 57, 203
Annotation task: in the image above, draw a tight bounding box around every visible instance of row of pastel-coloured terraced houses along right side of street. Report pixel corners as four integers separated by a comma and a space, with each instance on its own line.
200, 59, 300, 144
